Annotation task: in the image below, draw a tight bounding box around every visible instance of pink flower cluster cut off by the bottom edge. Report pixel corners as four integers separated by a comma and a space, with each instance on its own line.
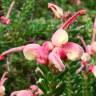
10, 85, 43, 96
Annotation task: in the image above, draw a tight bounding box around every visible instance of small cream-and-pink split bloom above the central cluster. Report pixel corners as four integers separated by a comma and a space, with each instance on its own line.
48, 3, 63, 19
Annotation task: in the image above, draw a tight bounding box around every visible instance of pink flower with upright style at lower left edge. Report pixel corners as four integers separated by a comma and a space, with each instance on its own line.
0, 72, 7, 96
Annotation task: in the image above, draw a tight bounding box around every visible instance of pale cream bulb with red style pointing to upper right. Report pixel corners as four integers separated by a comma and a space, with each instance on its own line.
51, 10, 86, 46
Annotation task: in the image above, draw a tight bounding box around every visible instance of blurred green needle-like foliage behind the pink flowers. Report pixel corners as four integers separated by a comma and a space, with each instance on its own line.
0, 0, 96, 96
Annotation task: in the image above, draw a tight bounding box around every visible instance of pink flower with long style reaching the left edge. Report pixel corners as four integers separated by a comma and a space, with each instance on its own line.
0, 42, 53, 64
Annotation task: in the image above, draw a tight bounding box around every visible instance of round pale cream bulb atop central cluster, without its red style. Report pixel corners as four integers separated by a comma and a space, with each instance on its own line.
51, 29, 68, 46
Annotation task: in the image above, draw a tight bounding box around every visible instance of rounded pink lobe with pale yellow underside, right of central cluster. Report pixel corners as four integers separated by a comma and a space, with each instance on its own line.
63, 42, 84, 61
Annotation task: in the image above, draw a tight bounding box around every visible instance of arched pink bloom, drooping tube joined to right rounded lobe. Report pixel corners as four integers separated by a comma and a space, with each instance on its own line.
48, 42, 84, 72
